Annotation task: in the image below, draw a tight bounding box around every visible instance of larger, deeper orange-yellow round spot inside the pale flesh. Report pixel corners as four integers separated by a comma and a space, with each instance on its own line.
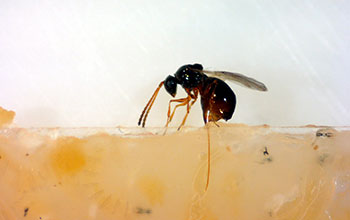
51, 137, 86, 175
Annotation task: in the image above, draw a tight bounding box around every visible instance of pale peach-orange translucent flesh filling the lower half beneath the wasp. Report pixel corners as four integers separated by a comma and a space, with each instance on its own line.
0, 106, 350, 220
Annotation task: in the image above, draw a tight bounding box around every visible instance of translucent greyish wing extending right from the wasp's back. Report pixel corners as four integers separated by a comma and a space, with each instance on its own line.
202, 70, 267, 91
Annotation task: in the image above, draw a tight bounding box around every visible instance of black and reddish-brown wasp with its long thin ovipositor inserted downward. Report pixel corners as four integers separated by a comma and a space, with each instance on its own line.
138, 63, 267, 190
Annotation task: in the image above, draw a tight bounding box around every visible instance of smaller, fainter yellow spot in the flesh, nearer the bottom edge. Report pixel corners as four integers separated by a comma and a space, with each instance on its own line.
138, 176, 165, 205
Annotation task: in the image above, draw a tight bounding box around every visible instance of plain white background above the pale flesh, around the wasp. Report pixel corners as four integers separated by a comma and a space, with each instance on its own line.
0, 0, 350, 127
